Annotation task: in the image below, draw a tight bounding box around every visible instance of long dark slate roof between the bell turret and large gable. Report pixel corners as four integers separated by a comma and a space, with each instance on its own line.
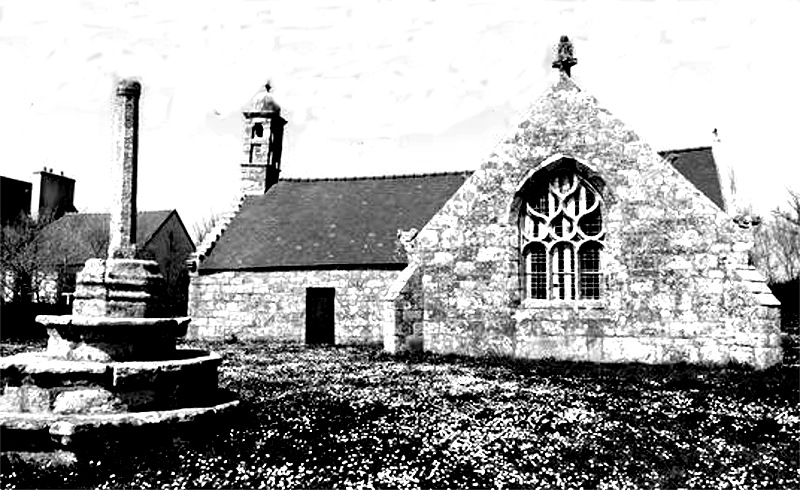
200, 172, 472, 272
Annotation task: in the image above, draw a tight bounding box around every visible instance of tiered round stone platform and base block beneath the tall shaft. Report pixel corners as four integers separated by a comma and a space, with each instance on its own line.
0, 259, 239, 463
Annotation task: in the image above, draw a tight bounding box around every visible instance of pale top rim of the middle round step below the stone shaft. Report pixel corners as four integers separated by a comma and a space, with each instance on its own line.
0, 349, 222, 374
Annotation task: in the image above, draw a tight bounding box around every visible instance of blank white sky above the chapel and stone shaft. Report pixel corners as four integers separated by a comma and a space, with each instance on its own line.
0, 0, 800, 227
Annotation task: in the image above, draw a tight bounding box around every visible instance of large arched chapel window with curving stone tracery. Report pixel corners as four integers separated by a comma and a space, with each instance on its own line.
519, 168, 605, 300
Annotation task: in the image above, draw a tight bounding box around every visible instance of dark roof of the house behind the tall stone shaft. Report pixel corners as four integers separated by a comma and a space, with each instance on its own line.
41, 211, 175, 265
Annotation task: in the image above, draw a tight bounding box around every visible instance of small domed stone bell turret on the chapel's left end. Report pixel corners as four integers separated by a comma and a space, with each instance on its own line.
241, 82, 286, 195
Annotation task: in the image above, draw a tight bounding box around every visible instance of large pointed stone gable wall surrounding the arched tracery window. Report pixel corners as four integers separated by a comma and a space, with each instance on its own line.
385, 73, 781, 367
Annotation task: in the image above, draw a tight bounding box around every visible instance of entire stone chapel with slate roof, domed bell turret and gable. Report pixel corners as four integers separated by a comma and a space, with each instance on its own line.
189, 37, 782, 368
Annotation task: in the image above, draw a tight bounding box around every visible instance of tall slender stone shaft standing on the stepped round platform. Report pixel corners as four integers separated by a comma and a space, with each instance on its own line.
108, 79, 142, 259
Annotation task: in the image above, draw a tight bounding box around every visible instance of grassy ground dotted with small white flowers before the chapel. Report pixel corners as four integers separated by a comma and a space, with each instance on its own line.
0, 343, 800, 488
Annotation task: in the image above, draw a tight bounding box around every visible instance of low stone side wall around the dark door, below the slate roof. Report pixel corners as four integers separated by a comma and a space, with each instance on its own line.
187, 269, 399, 344
